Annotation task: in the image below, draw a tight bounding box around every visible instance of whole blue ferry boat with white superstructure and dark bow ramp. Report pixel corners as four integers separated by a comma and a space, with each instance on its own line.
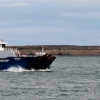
0, 40, 56, 71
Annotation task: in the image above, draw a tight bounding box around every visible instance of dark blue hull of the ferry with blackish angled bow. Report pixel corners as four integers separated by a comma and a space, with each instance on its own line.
0, 55, 56, 70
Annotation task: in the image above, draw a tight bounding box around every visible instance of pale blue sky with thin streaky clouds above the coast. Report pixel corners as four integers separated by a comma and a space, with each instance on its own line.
0, 0, 100, 46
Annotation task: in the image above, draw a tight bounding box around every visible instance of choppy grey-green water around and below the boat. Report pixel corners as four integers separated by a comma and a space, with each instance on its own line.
0, 57, 100, 100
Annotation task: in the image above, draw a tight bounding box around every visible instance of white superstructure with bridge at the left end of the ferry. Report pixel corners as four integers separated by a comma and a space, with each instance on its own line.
0, 40, 20, 58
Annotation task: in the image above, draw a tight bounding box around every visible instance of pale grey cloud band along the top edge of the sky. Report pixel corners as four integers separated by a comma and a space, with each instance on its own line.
0, 0, 100, 7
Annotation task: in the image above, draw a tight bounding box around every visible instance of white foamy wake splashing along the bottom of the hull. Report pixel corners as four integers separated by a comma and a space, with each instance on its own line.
3, 66, 51, 72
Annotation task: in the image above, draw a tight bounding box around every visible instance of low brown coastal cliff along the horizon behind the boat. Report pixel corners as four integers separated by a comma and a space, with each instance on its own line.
8, 45, 100, 56
